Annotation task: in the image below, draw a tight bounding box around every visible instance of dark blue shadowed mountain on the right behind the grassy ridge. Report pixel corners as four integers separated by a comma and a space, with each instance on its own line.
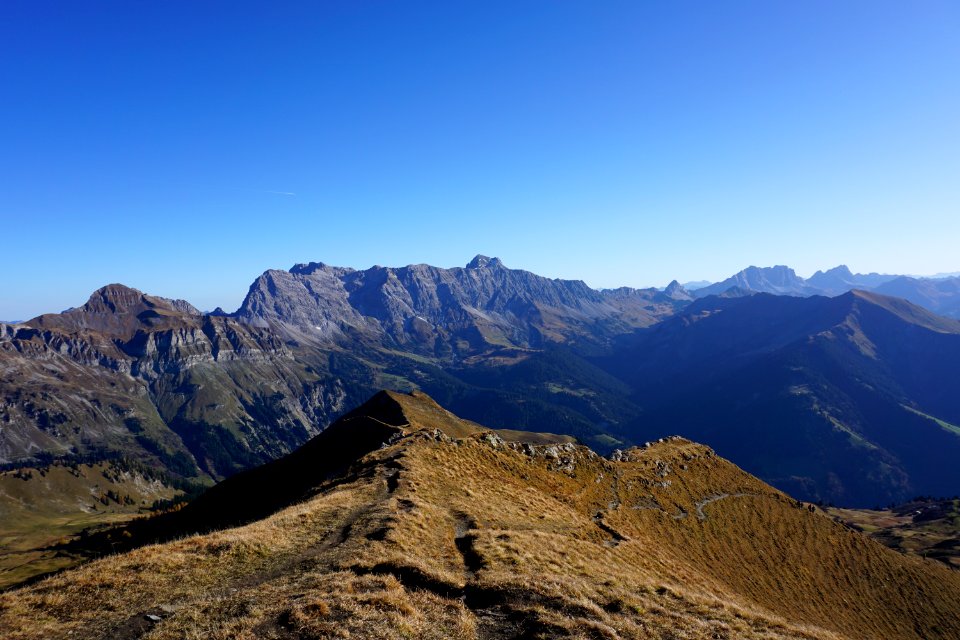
606, 292, 960, 506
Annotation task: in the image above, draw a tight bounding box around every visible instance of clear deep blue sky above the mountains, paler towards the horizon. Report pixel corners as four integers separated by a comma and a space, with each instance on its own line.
0, 0, 960, 319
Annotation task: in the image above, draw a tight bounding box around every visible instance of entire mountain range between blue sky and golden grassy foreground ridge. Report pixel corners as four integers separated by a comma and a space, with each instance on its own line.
0, 256, 960, 505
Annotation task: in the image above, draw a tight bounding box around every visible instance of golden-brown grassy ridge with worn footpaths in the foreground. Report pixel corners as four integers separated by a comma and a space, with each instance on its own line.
0, 392, 960, 640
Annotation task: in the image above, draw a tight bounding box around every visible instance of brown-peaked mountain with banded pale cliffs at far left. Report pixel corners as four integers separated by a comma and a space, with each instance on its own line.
0, 285, 360, 477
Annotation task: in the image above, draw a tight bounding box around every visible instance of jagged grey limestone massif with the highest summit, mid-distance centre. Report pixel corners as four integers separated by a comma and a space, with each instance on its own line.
235, 256, 677, 354
